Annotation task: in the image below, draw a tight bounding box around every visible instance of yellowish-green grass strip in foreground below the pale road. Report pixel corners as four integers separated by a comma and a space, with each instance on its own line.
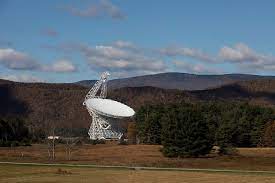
0, 164, 275, 183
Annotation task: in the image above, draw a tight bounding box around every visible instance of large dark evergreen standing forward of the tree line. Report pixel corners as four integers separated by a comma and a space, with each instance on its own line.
162, 106, 213, 157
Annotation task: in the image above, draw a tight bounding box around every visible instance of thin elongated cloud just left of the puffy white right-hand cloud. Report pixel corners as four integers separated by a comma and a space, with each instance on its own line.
159, 47, 217, 63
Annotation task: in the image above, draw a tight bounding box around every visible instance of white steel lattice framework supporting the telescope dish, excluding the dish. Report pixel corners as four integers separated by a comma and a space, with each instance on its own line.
83, 72, 122, 140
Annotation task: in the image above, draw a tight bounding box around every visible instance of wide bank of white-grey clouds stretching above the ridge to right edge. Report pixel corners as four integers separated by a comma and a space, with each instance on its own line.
41, 40, 275, 77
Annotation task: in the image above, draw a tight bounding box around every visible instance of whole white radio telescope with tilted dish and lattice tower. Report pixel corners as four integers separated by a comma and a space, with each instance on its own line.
83, 72, 135, 140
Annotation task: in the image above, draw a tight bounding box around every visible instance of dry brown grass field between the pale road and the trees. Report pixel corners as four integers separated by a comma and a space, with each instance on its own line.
0, 143, 275, 171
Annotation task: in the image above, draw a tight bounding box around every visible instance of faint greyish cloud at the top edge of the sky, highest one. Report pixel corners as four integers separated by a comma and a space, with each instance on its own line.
64, 0, 126, 20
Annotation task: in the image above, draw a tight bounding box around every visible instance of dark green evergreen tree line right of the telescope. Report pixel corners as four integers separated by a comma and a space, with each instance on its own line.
136, 102, 274, 156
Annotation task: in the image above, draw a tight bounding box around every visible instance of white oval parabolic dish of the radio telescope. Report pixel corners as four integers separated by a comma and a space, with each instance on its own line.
85, 98, 135, 118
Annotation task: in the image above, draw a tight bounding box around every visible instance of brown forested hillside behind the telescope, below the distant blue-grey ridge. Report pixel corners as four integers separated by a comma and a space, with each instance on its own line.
0, 77, 275, 140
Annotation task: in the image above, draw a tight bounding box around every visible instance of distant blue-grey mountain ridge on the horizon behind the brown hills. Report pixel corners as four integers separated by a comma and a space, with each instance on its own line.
75, 72, 275, 91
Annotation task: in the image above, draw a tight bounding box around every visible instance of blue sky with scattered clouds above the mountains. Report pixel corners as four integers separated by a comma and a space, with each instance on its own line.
0, 0, 275, 82
